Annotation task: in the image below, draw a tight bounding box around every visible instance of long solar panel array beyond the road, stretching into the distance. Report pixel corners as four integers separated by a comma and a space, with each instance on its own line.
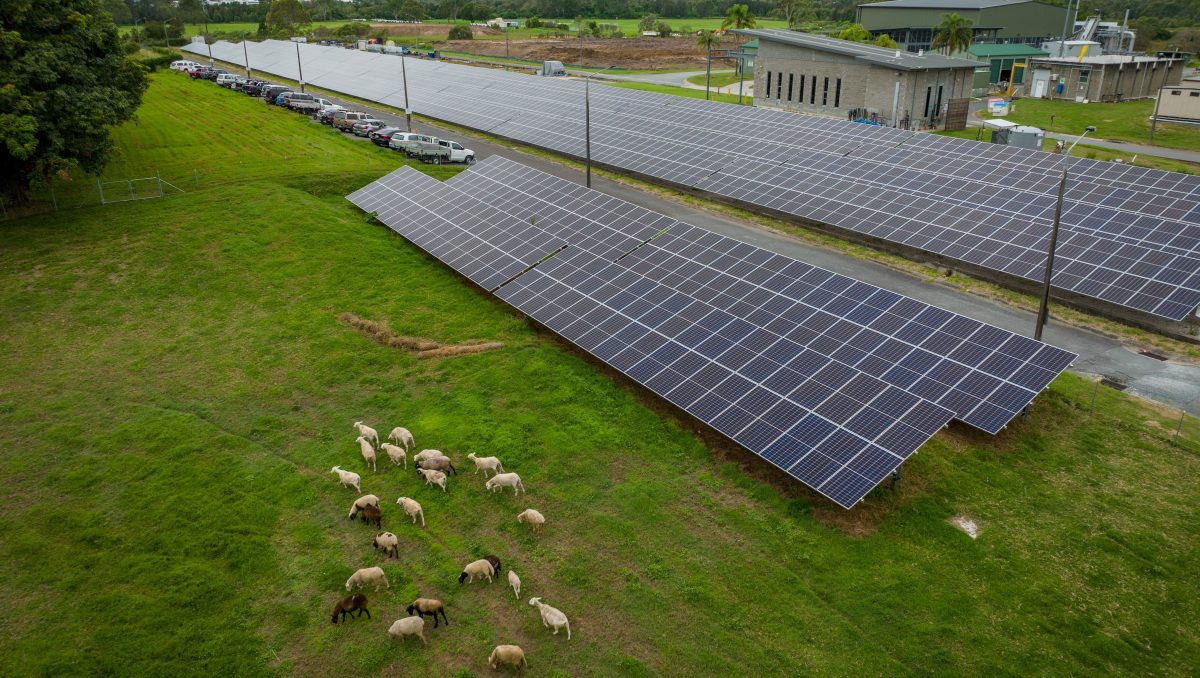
187, 41, 1200, 320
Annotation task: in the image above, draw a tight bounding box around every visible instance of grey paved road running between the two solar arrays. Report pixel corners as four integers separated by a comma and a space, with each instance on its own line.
312, 92, 1200, 415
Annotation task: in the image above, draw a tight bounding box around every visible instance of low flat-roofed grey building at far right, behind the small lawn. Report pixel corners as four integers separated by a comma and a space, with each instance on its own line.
1027, 54, 1187, 102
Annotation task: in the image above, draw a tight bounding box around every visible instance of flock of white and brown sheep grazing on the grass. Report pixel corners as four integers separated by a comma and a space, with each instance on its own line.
331, 421, 571, 670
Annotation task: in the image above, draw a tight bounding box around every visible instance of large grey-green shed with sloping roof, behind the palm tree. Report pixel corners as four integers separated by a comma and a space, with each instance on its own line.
856, 0, 1067, 52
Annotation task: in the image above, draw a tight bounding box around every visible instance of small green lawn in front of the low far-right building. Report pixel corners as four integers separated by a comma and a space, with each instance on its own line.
1004, 98, 1200, 151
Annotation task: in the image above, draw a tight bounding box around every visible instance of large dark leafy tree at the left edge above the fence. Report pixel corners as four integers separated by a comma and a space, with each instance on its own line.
0, 0, 146, 202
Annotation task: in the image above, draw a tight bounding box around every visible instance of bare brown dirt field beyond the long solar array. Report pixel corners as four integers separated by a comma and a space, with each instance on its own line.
436, 36, 715, 70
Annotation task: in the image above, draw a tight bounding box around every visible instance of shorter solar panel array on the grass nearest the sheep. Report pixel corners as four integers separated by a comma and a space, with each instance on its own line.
347, 156, 1075, 508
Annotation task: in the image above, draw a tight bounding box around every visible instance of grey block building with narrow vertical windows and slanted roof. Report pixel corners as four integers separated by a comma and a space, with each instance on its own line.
734, 29, 985, 128
